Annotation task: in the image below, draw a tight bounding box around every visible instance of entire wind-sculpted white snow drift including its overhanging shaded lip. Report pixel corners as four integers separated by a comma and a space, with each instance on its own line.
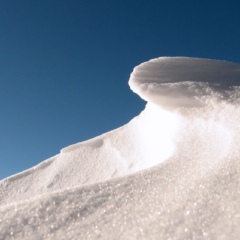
0, 57, 240, 240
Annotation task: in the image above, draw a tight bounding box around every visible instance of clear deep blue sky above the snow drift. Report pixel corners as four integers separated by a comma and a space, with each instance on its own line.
0, 0, 240, 179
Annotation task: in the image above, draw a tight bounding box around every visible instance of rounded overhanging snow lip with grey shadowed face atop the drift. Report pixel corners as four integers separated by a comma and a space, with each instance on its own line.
129, 57, 240, 109
